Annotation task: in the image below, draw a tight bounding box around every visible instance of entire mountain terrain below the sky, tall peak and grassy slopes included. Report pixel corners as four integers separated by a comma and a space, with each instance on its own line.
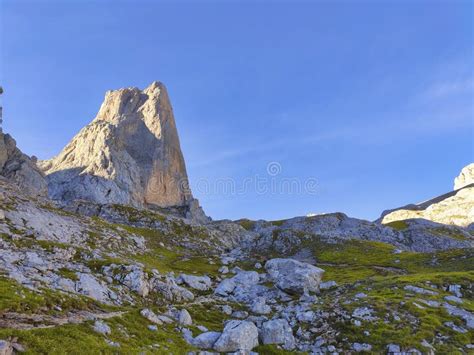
0, 82, 474, 355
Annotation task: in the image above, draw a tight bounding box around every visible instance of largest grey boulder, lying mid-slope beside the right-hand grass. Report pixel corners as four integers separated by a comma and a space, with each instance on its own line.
265, 259, 324, 294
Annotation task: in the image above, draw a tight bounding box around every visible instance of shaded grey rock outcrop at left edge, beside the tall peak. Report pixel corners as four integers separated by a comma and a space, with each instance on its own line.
0, 133, 48, 196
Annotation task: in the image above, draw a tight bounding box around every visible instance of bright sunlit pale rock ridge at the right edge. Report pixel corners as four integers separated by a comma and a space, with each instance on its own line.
381, 164, 474, 229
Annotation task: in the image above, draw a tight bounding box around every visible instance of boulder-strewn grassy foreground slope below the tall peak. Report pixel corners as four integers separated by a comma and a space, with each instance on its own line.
0, 178, 474, 354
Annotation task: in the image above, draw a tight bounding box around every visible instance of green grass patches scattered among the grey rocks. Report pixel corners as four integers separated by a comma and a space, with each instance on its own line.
0, 206, 474, 354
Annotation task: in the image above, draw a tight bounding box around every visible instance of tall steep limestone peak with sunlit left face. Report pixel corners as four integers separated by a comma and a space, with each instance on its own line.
40, 82, 193, 211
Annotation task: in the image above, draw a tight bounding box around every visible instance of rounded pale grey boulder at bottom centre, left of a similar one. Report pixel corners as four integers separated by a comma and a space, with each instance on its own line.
214, 320, 258, 352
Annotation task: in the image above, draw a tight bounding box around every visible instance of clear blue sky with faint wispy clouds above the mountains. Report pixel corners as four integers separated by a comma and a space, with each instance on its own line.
0, 0, 474, 219
